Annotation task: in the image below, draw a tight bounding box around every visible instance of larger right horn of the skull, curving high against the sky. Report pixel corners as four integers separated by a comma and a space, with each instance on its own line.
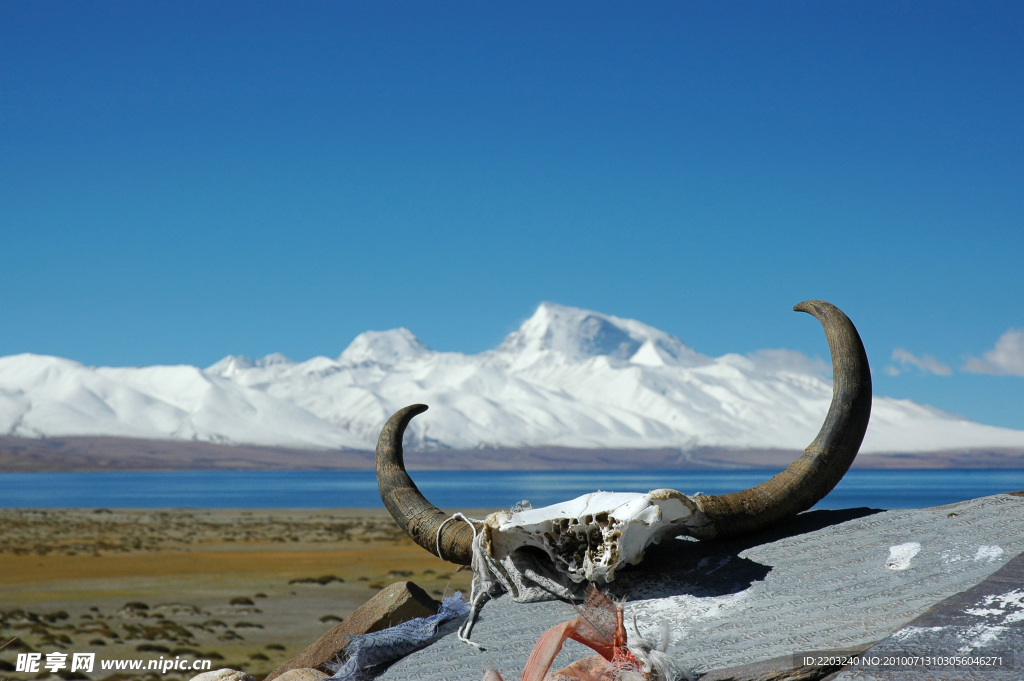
693, 300, 871, 538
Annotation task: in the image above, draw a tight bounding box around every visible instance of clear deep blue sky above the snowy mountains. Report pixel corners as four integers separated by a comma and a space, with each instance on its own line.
0, 0, 1024, 428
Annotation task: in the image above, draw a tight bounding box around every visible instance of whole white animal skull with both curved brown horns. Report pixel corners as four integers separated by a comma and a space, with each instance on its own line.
377, 300, 871, 569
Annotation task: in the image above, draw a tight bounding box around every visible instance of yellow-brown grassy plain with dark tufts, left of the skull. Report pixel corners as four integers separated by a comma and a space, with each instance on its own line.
0, 509, 485, 681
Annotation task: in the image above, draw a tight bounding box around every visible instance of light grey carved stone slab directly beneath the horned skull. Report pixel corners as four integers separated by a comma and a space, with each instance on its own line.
381, 495, 1024, 681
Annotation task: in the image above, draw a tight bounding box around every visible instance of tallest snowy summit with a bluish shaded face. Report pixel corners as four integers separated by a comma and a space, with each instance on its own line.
498, 302, 709, 366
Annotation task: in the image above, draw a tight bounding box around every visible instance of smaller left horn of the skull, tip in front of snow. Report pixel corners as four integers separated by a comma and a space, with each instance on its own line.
377, 405, 473, 565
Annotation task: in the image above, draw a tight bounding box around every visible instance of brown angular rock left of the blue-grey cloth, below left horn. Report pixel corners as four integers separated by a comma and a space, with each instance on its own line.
264, 582, 440, 681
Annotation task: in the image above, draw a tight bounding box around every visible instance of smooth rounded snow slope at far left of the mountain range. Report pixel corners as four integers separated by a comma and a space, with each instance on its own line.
0, 354, 365, 449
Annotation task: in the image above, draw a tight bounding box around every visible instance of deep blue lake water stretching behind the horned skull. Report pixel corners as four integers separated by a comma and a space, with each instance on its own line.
0, 469, 1024, 509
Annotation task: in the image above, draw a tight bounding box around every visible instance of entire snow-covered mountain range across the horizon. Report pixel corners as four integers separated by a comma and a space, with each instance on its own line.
0, 303, 1024, 453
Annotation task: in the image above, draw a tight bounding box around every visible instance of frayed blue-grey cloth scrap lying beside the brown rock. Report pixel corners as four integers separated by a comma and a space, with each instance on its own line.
329, 592, 469, 681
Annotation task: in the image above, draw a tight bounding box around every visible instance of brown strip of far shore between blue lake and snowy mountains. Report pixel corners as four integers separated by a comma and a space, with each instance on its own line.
0, 436, 1024, 473
